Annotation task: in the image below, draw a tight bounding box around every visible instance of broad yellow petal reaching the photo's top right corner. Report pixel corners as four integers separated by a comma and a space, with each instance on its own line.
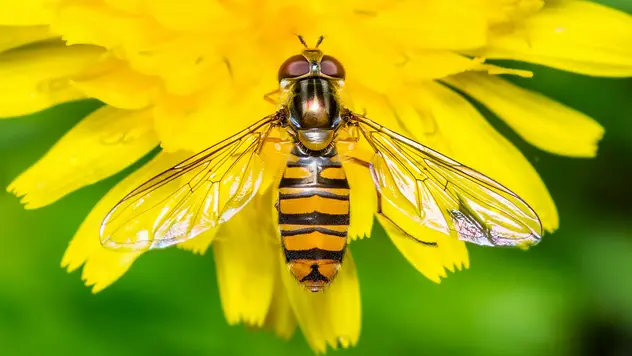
473, 1, 632, 77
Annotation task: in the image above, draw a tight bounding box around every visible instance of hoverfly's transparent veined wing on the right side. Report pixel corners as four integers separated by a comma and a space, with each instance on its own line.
351, 115, 542, 246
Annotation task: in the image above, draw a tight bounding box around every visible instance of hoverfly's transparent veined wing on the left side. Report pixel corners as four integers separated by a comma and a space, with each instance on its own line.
100, 115, 278, 250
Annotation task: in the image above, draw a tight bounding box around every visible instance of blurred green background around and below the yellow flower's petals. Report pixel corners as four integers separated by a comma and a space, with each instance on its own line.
0, 0, 632, 356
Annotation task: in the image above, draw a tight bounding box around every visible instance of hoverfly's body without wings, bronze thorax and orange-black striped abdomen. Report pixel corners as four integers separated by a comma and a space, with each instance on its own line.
277, 64, 350, 291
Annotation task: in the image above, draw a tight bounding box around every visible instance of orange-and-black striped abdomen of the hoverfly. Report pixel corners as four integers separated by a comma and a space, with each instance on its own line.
277, 145, 349, 291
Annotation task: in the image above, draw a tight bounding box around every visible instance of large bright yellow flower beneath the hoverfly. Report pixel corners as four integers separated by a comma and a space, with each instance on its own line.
0, 0, 632, 352
